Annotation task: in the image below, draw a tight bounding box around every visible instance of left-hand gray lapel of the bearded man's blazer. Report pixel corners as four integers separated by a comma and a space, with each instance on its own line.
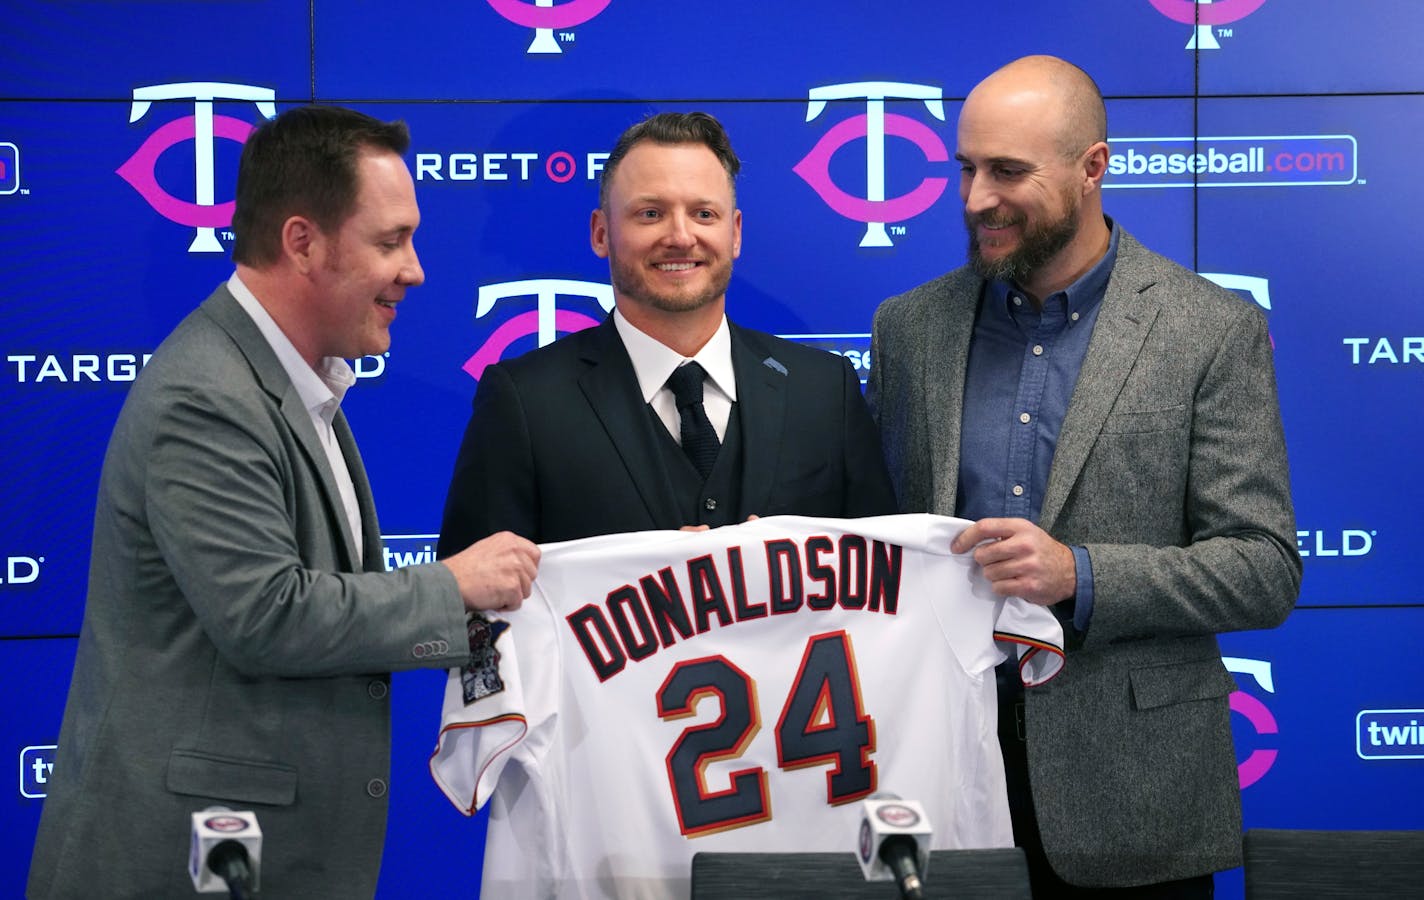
923, 272, 984, 516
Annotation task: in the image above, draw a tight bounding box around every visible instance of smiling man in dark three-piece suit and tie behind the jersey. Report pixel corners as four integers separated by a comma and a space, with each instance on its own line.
439, 113, 896, 557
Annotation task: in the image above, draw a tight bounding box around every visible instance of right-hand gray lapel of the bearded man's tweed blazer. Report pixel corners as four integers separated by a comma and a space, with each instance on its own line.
1038, 232, 1158, 531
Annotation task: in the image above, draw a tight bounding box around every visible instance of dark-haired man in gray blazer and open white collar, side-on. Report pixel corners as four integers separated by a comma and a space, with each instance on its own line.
28, 107, 538, 900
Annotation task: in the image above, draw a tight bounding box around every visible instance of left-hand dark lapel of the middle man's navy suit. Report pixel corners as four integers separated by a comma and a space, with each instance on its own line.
578, 316, 686, 528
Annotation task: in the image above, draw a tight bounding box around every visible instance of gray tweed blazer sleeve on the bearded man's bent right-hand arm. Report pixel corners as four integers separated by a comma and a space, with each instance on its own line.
1084, 306, 1302, 647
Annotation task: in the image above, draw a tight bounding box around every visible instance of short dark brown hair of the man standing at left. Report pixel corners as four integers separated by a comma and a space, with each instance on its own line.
232, 107, 410, 266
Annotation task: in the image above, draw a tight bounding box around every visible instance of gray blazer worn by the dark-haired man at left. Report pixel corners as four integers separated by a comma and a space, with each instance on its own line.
28, 288, 468, 900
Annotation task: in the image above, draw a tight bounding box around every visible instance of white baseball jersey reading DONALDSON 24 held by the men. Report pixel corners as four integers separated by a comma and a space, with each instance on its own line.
430, 514, 1062, 900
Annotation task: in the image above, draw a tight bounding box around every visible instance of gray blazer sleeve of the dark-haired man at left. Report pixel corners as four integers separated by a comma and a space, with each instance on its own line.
140, 375, 468, 676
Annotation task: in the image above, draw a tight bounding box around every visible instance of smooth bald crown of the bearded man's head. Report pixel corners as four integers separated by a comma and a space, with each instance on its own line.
964, 56, 1108, 158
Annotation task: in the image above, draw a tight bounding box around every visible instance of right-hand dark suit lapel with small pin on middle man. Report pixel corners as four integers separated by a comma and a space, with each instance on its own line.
728, 322, 792, 513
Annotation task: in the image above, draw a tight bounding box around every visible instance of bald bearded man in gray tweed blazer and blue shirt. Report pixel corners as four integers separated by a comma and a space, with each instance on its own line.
870, 57, 1300, 897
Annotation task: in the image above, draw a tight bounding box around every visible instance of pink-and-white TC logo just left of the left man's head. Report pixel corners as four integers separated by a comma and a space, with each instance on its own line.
117, 81, 276, 253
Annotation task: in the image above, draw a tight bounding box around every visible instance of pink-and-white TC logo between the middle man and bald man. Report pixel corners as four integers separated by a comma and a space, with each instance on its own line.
792, 81, 950, 246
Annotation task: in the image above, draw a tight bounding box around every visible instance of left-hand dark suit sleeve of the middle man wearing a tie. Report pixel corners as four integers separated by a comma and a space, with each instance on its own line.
436, 365, 541, 557
